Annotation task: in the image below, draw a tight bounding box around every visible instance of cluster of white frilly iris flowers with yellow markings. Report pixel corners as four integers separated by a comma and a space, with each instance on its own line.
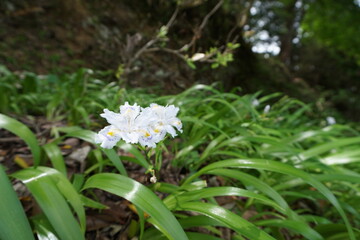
95, 102, 182, 148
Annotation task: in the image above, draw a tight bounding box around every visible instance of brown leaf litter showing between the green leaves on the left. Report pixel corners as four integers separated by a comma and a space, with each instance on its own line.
0, 117, 191, 240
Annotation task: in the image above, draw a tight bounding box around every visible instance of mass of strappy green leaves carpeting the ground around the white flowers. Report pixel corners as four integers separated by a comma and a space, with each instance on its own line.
0, 68, 360, 240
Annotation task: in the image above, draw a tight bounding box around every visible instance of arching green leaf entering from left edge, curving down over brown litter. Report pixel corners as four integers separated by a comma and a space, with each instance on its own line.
0, 114, 41, 166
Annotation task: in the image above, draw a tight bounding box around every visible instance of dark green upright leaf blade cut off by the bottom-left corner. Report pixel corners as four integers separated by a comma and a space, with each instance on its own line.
0, 165, 34, 240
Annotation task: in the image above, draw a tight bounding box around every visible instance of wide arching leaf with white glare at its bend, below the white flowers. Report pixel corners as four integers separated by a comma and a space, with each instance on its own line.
83, 173, 188, 240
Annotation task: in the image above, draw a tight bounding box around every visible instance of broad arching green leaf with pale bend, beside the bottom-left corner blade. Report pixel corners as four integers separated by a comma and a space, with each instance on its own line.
13, 167, 85, 240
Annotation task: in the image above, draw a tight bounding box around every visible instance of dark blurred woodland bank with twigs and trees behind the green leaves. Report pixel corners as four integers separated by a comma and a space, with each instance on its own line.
0, 0, 360, 121
